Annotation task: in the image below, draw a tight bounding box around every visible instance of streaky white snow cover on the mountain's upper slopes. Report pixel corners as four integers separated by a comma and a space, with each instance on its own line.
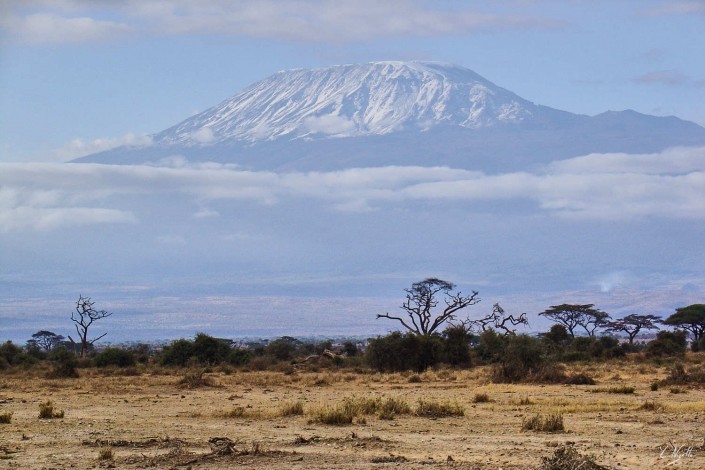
154, 62, 544, 145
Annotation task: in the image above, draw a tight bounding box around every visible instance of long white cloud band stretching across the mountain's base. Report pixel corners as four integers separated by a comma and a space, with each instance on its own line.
0, 148, 705, 231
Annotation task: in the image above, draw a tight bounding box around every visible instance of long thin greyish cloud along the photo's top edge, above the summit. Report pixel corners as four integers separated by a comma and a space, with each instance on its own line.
2, 0, 558, 43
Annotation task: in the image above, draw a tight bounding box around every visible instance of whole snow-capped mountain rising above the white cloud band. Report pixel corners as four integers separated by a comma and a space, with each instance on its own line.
78, 62, 705, 171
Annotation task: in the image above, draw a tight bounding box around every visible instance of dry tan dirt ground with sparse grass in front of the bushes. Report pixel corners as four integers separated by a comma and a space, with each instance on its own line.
0, 362, 705, 469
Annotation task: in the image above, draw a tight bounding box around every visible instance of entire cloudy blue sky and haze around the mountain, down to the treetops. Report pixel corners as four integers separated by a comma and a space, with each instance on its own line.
0, 0, 705, 341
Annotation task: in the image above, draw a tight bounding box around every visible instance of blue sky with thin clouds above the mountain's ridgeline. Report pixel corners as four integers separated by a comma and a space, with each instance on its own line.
0, 0, 705, 161
